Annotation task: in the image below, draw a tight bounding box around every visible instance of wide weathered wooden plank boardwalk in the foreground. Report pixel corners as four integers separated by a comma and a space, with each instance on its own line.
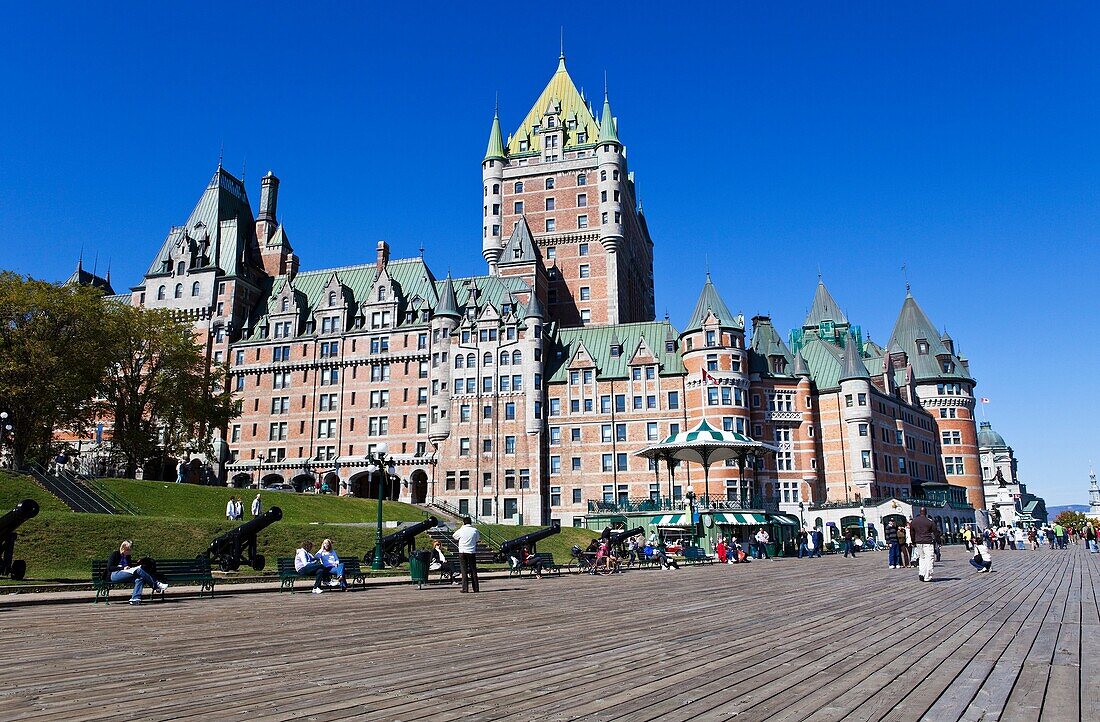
0, 547, 1100, 722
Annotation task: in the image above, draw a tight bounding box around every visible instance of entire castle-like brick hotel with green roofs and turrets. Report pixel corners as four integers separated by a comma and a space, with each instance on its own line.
78, 57, 1029, 525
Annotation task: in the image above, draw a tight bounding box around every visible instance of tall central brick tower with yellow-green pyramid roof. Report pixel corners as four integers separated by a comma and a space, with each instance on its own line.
482, 56, 653, 326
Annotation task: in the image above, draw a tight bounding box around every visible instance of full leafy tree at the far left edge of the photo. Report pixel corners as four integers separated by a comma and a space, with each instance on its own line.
0, 272, 111, 468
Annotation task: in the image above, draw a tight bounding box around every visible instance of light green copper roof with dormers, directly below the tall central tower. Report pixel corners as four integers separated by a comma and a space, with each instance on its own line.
547, 321, 686, 383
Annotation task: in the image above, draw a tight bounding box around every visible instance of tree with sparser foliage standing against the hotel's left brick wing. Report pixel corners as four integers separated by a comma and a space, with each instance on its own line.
102, 305, 235, 475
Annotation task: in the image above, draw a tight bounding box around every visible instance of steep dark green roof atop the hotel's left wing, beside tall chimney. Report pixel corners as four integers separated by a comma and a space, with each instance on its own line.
145, 165, 255, 275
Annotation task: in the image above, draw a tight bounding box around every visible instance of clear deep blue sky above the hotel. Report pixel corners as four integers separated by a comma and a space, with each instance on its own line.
0, 2, 1100, 504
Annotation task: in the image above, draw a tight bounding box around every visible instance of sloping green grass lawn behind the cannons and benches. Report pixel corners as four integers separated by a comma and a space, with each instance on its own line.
0, 472, 595, 588
